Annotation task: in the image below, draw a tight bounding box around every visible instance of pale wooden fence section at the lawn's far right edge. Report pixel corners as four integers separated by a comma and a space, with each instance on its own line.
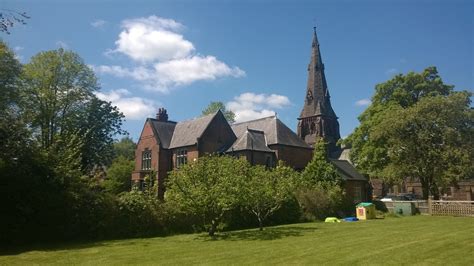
428, 199, 474, 217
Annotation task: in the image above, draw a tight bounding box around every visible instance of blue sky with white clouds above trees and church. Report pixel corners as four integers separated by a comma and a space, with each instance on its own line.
0, 0, 474, 140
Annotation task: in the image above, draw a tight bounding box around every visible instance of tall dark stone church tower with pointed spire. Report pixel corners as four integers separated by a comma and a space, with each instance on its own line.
298, 27, 341, 151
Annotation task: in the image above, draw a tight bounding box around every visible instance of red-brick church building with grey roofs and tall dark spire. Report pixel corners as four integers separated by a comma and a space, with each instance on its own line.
132, 29, 369, 202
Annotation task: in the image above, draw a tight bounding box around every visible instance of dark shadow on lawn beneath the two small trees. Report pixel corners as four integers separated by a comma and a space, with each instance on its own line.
196, 226, 317, 241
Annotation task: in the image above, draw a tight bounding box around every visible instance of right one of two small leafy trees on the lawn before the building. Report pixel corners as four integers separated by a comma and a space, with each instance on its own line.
242, 162, 297, 231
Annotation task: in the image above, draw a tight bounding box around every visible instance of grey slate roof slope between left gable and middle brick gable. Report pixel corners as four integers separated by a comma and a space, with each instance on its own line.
169, 111, 222, 149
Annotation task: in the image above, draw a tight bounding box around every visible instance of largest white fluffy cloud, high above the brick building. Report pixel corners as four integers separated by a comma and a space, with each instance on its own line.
96, 16, 245, 93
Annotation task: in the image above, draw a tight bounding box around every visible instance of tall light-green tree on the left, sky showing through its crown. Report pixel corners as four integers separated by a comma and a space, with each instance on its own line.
22, 48, 98, 149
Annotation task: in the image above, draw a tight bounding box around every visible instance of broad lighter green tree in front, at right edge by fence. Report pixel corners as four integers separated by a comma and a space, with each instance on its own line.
372, 92, 474, 198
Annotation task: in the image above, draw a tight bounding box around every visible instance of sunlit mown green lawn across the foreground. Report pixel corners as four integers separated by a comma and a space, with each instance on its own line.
0, 216, 474, 265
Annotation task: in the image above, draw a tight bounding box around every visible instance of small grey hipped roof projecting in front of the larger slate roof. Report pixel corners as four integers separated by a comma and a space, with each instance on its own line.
227, 129, 273, 152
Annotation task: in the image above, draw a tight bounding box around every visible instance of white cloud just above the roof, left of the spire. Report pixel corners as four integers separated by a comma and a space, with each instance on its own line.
226, 92, 291, 122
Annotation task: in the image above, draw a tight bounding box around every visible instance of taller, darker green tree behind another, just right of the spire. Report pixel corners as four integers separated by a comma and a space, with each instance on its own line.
343, 67, 453, 177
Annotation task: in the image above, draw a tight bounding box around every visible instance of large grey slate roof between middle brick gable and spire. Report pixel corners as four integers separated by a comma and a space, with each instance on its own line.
232, 116, 311, 148
